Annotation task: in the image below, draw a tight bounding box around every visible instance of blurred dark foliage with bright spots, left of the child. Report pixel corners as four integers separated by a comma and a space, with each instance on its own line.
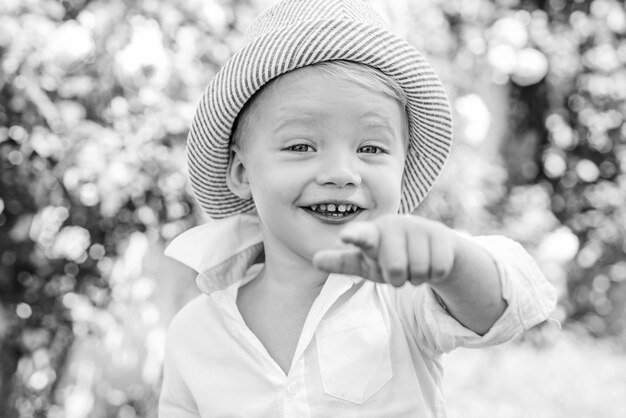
0, 0, 253, 418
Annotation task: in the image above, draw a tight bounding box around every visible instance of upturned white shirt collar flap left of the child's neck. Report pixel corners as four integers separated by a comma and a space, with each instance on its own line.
165, 214, 362, 294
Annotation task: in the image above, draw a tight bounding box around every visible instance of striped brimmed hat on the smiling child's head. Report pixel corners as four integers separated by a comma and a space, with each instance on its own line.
187, 0, 452, 219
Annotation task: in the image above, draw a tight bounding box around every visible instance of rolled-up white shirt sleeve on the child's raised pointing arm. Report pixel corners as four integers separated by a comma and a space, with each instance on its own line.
392, 236, 556, 355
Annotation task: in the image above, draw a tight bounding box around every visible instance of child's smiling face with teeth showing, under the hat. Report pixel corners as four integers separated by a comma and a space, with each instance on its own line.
231, 67, 407, 260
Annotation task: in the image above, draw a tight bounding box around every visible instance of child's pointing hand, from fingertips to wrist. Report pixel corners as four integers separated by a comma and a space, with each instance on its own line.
313, 215, 457, 287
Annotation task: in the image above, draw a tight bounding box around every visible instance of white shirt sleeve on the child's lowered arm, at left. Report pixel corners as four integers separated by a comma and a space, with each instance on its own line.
159, 326, 200, 418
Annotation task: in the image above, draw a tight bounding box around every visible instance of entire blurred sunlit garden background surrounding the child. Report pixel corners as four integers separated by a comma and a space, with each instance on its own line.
0, 0, 626, 418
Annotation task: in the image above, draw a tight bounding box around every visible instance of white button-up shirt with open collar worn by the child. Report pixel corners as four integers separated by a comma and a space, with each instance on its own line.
159, 215, 556, 418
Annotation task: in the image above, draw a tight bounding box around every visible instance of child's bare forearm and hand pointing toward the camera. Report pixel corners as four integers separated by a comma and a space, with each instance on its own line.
313, 215, 506, 335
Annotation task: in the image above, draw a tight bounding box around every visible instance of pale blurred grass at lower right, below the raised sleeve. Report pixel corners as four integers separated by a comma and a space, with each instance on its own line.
444, 332, 626, 418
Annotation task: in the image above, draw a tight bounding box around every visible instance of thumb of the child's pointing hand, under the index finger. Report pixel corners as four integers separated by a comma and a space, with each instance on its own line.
313, 245, 384, 283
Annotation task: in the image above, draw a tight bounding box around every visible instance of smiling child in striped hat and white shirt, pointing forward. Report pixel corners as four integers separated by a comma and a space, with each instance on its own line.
159, 0, 555, 418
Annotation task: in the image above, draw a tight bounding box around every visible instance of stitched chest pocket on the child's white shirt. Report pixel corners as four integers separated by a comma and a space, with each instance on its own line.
316, 309, 392, 404
